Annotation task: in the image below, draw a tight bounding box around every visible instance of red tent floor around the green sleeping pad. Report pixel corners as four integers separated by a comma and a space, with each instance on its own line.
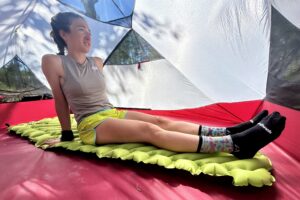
0, 100, 300, 200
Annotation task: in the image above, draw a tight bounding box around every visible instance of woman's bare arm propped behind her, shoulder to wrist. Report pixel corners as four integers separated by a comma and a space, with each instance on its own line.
42, 55, 71, 130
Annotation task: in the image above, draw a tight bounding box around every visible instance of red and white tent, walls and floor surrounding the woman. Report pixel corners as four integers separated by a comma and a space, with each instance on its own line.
0, 0, 300, 199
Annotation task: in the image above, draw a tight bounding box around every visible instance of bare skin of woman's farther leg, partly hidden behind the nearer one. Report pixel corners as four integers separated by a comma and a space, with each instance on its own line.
126, 111, 200, 135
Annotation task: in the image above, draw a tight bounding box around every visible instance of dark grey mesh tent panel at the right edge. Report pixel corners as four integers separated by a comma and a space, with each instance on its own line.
266, 8, 300, 110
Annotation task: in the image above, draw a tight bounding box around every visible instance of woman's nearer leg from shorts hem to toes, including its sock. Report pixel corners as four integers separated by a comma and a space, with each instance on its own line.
96, 112, 286, 158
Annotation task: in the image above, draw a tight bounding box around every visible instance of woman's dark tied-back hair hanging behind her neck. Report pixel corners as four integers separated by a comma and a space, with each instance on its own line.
50, 12, 83, 55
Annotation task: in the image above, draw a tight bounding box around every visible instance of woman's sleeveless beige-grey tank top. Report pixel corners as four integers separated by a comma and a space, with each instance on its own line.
60, 56, 113, 123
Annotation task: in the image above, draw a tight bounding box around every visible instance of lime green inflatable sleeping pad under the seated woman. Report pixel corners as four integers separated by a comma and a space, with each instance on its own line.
8, 115, 275, 187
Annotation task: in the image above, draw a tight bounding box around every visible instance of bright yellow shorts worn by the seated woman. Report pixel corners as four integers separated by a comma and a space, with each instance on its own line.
77, 108, 127, 145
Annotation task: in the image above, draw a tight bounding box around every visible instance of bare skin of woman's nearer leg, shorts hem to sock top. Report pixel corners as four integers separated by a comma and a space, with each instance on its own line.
96, 118, 199, 152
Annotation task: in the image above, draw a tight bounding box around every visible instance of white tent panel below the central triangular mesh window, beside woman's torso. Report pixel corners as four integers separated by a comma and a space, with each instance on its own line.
103, 59, 213, 109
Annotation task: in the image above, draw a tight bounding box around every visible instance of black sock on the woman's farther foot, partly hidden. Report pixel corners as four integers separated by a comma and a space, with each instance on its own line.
226, 110, 268, 135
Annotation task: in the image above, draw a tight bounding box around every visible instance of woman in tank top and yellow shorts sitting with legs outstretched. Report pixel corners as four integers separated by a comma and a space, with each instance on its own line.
42, 12, 285, 158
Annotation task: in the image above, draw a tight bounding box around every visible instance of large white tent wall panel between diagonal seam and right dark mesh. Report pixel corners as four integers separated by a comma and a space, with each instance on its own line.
133, 0, 271, 104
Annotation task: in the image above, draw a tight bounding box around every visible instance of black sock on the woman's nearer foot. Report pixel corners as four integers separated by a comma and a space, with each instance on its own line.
231, 112, 286, 159
